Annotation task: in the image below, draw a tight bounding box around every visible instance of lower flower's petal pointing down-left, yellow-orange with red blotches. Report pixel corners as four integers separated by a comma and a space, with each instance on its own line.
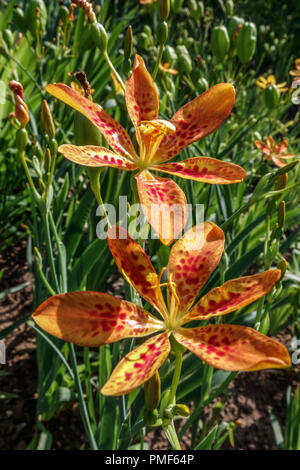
101, 333, 170, 396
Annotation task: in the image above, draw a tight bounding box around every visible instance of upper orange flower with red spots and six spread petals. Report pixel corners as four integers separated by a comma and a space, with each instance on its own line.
46, 56, 246, 244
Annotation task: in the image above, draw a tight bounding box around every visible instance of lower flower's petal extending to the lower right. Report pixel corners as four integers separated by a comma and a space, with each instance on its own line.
174, 324, 291, 371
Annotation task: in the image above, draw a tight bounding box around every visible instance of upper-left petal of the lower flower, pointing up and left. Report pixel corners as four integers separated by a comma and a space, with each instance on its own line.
107, 226, 167, 314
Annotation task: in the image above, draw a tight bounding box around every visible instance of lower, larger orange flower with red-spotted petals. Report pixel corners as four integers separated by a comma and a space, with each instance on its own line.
33, 222, 290, 396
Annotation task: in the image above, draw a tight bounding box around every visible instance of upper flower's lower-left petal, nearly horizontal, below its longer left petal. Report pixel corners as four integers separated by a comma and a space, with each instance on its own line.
58, 144, 136, 170
